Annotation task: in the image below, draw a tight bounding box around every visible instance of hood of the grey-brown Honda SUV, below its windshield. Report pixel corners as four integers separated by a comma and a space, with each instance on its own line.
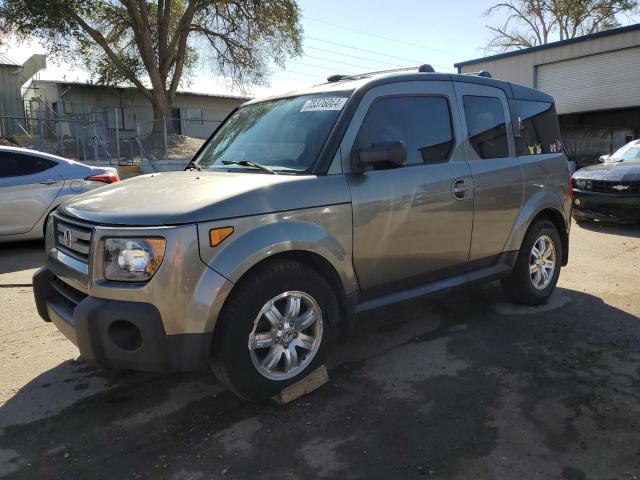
60, 171, 349, 226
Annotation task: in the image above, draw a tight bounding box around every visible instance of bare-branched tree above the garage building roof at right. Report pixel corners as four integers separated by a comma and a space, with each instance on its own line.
485, 0, 638, 51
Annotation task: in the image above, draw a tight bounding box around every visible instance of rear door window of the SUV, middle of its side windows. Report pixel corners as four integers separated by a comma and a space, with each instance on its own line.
462, 95, 509, 158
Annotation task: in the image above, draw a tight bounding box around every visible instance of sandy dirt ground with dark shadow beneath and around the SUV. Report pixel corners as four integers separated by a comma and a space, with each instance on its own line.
0, 225, 640, 480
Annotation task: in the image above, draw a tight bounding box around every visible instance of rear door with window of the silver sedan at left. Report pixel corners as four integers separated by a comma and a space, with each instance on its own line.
0, 152, 64, 235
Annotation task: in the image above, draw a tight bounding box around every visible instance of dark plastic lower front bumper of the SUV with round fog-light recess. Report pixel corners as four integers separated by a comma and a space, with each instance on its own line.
33, 267, 213, 372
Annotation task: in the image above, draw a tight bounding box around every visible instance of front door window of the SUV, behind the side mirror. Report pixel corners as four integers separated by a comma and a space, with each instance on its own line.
354, 96, 453, 164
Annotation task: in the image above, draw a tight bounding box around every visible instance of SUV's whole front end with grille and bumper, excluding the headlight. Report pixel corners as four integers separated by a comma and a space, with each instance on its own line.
33, 212, 233, 372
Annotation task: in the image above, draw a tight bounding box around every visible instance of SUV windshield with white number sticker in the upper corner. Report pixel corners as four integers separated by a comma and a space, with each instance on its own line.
195, 92, 349, 173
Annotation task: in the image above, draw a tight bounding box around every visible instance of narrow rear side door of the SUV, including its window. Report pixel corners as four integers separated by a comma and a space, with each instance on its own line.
455, 82, 523, 268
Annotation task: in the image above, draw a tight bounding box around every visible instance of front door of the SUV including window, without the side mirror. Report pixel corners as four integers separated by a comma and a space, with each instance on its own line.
341, 81, 473, 297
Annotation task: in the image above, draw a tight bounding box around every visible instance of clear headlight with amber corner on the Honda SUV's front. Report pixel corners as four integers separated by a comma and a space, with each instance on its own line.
104, 238, 167, 282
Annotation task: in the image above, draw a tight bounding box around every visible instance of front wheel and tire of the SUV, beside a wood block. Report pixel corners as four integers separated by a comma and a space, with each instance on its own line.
210, 260, 339, 402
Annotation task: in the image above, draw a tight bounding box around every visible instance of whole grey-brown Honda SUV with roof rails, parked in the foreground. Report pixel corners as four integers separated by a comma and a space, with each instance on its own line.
34, 65, 572, 401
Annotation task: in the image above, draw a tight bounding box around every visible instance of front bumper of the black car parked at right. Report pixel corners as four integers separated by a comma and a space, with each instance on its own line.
573, 189, 640, 223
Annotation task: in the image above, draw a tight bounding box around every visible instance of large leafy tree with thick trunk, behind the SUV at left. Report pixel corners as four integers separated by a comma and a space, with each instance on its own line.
0, 0, 302, 128
